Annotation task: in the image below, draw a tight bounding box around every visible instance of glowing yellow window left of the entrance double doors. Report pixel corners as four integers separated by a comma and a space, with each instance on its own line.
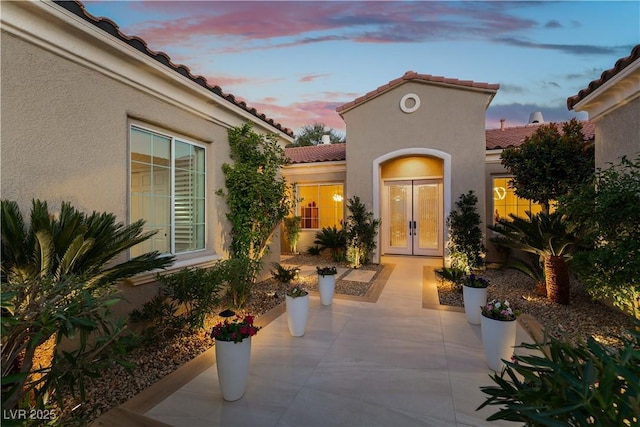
297, 184, 344, 229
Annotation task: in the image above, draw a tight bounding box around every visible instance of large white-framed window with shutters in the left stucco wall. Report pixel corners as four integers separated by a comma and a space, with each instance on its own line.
130, 126, 206, 256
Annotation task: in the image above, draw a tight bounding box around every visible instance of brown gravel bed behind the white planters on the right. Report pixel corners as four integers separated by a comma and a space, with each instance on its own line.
438, 268, 633, 345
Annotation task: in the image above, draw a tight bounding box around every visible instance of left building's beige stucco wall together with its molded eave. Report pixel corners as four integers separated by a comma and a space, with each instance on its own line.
0, 2, 291, 314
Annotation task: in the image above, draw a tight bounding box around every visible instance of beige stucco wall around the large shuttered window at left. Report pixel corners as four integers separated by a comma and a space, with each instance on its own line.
1, 34, 229, 258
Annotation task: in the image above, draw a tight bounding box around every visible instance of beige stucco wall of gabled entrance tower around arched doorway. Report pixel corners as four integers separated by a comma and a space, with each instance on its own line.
343, 81, 491, 258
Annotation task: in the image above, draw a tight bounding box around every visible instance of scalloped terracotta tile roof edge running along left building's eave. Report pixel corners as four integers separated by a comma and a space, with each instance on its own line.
54, 0, 294, 136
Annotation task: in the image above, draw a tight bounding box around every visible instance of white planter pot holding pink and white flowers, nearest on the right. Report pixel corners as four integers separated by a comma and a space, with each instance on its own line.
480, 316, 517, 372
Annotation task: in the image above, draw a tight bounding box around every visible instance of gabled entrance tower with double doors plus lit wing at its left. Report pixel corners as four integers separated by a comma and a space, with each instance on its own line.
284, 71, 499, 262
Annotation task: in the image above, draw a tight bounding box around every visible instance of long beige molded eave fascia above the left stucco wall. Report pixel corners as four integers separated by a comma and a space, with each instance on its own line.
0, 0, 293, 143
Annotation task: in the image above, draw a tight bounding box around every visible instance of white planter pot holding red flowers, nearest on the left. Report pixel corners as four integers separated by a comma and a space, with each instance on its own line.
215, 337, 251, 402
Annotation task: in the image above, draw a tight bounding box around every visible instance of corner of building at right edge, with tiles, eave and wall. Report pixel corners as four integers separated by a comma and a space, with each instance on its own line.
567, 45, 640, 169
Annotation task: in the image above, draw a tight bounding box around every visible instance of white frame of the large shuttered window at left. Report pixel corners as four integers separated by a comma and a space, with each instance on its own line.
127, 122, 209, 256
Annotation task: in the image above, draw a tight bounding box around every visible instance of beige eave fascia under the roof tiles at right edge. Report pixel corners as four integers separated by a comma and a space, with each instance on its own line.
573, 59, 640, 121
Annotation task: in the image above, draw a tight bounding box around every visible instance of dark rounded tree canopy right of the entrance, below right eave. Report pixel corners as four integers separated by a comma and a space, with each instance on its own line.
500, 119, 595, 213
